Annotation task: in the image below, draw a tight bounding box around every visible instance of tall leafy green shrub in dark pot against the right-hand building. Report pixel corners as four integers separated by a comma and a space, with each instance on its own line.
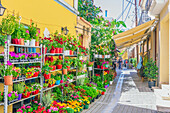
144, 58, 158, 88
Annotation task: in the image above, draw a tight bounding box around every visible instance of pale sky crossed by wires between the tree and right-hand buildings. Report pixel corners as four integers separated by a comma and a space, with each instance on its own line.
94, 0, 138, 29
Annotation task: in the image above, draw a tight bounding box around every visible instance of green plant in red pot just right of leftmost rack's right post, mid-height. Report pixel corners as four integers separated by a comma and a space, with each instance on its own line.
42, 63, 52, 79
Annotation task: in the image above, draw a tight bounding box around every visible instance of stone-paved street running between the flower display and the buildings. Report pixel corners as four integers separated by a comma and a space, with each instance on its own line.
83, 70, 169, 113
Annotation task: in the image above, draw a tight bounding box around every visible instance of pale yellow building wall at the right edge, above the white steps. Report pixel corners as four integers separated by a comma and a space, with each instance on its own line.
160, 4, 169, 84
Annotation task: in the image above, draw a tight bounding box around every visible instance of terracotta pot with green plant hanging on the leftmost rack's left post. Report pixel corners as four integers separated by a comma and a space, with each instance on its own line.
0, 61, 13, 85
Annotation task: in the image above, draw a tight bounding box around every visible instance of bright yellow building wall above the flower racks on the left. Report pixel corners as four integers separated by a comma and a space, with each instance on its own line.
0, 0, 77, 35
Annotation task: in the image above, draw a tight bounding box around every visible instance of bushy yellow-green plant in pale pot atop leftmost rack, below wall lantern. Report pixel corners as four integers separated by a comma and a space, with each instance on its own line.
1, 15, 18, 43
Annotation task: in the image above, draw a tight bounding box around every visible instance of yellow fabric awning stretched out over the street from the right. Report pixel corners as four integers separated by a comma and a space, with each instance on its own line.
114, 20, 155, 48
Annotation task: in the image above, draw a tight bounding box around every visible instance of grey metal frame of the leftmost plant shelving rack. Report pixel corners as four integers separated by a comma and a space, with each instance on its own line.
0, 40, 43, 113
